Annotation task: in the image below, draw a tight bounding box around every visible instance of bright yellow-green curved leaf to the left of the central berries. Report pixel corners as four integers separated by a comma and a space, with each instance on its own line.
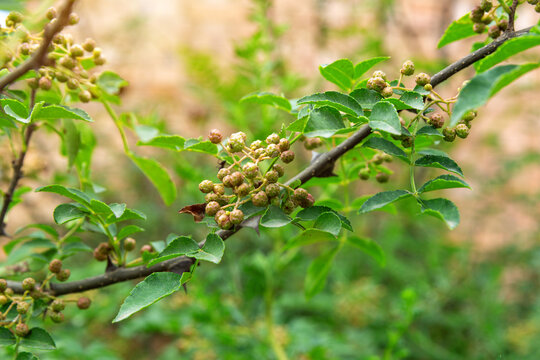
129, 154, 176, 205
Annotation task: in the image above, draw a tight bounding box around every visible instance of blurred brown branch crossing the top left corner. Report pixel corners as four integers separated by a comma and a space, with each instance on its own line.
0, 0, 76, 92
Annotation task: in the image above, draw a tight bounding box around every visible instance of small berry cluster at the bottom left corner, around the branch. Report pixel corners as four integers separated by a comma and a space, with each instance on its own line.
0, 259, 91, 337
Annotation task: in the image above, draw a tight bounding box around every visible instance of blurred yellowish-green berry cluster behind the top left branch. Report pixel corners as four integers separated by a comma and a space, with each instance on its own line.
0, 7, 106, 102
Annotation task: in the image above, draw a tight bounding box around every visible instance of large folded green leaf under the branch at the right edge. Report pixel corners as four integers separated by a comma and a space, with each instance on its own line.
449, 63, 540, 126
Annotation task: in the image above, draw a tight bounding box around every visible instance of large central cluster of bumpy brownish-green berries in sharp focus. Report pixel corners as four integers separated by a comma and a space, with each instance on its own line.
199, 130, 314, 229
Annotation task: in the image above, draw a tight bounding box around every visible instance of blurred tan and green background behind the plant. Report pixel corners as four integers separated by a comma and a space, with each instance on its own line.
0, 0, 540, 360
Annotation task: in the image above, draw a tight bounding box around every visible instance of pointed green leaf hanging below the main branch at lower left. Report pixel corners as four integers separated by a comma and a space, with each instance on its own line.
113, 272, 181, 323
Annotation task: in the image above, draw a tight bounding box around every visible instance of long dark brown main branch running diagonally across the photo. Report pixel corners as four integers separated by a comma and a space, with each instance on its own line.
3, 21, 530, 295
